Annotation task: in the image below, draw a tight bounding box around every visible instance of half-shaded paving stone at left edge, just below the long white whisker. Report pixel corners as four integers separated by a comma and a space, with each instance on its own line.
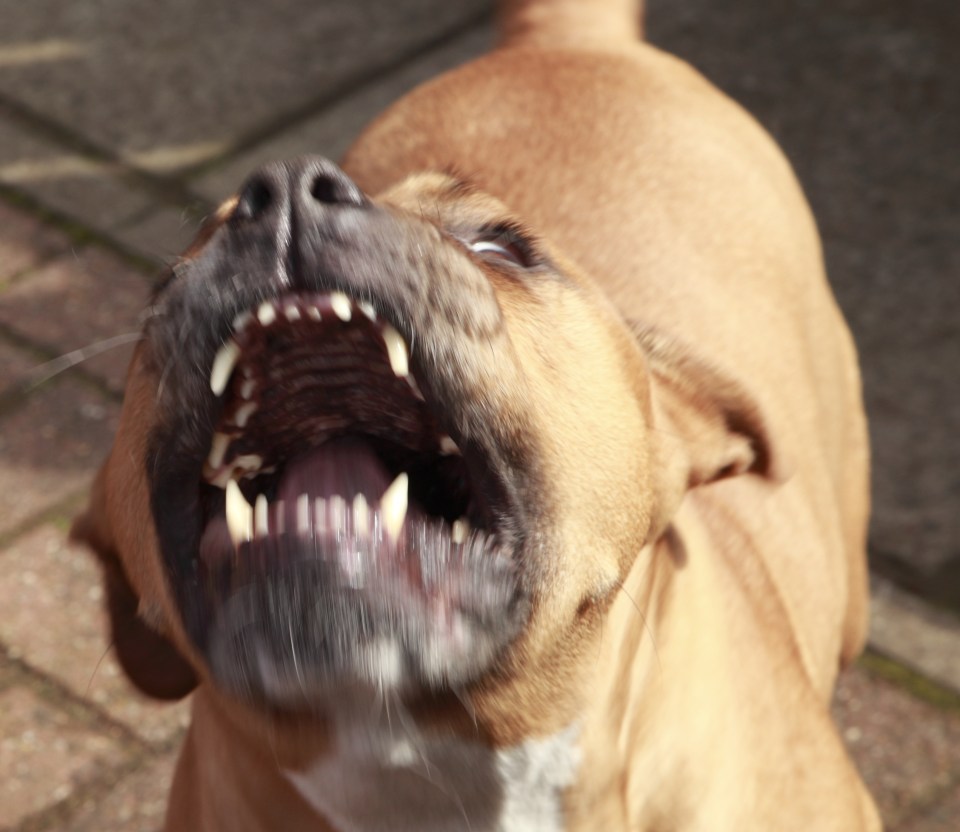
0, 379, 119, 535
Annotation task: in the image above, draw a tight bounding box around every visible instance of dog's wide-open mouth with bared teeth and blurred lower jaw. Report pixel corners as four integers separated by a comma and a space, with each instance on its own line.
170, 291, 518, 698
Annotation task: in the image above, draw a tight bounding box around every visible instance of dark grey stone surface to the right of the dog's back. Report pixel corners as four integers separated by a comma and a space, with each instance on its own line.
648, 0, 960, 609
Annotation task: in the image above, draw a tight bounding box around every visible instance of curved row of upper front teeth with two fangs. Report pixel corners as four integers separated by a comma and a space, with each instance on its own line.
210, 292, 406, 396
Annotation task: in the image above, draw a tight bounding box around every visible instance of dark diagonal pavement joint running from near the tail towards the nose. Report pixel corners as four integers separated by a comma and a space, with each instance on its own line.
187, 9, 492, 181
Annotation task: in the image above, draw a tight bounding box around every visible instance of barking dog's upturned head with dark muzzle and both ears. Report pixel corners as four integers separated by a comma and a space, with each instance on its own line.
75, 158, 780, 744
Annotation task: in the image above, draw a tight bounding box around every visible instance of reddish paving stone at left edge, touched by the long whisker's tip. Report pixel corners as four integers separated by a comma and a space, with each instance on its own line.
0, 245, 150, 392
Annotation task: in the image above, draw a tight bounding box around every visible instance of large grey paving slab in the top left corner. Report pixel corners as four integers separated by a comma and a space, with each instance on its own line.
0, 0, 489, 171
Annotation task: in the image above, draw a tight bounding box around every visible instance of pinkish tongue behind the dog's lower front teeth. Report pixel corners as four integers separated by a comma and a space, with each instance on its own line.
277, 439, 390, 505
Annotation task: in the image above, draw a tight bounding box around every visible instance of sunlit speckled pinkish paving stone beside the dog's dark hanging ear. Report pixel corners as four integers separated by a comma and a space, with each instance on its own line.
0, 525, 189, 742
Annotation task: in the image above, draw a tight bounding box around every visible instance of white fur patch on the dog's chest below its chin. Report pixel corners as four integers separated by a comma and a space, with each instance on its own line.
286, 726, 579, 832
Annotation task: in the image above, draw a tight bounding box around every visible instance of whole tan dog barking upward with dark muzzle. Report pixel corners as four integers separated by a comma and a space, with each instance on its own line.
75, 0, 879, 832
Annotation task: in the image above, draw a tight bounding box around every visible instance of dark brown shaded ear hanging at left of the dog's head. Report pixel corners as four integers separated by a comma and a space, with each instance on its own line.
70, 468, 197, 700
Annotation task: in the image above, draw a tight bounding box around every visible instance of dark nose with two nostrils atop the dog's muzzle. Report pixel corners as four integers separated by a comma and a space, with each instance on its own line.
234, 156, 366, 222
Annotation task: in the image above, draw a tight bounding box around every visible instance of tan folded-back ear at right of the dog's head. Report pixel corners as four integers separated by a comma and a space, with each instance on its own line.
631, 323, 784, 526
